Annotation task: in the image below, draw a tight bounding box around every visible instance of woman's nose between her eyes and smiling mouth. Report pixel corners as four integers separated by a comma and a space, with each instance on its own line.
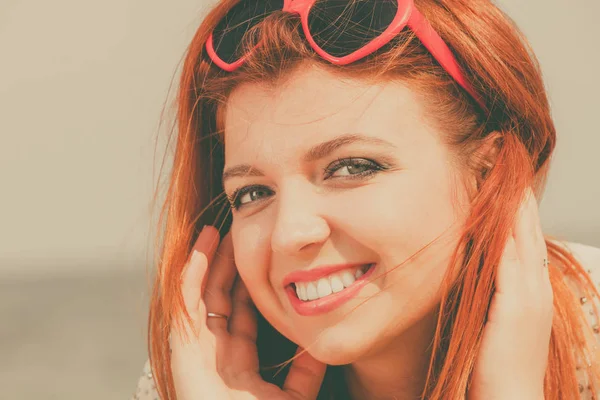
271, 180, 331, 255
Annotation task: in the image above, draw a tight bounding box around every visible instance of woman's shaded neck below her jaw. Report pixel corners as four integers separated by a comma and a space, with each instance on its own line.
344, 312, 437, 400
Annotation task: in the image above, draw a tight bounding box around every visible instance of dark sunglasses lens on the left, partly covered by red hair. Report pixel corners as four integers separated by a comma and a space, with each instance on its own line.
213, 0, 283, 64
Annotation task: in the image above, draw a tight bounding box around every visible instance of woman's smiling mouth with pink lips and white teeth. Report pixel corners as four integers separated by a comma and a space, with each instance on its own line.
286, 264, 375, 316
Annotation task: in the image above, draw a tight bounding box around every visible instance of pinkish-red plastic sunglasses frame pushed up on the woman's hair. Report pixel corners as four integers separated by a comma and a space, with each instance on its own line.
206, 0, 486, 110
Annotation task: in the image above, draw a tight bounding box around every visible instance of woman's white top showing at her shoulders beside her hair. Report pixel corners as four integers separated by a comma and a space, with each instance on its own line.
132, 242, 600, 400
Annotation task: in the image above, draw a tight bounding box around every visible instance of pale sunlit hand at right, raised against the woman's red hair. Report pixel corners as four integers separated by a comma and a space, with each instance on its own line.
467, 189, 553, 400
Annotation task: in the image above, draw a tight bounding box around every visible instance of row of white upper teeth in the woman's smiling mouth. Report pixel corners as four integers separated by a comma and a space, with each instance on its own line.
295, 265, 369, 301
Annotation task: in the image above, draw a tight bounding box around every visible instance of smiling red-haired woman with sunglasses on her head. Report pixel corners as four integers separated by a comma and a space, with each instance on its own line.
136, 0, 600, 400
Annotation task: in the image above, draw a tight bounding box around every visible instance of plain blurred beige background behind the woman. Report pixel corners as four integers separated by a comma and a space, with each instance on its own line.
0, 0, 600, 399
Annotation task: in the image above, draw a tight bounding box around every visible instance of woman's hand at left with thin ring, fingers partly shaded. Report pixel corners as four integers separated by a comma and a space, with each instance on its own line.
171, 226, 326, 400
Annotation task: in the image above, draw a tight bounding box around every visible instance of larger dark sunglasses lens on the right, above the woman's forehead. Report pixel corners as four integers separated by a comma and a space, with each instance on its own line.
308, 0, 398, 57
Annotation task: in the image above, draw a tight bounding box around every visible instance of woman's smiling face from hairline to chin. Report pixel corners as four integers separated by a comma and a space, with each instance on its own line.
224, 63, 468, 365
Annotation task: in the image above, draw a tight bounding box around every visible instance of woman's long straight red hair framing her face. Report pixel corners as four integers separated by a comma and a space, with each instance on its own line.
148, 0, 600, 400
